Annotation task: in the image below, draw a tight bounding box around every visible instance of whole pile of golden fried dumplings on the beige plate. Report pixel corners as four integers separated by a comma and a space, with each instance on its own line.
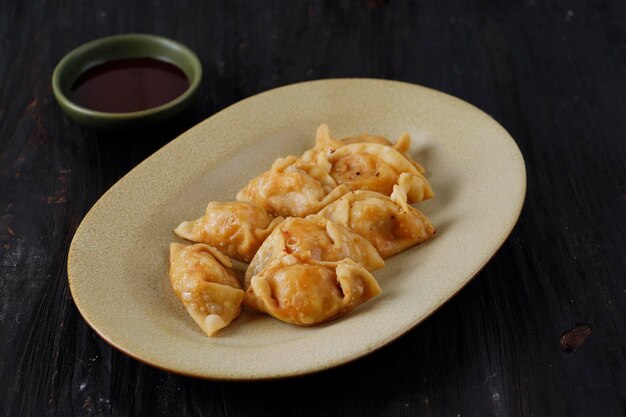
170, 124, 435, 336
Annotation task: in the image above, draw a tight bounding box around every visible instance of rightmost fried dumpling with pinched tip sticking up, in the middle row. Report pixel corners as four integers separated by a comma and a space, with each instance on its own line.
318, 180, 436, 258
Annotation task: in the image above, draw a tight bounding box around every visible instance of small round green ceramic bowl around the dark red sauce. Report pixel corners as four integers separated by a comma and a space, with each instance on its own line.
52, 34, 202, 128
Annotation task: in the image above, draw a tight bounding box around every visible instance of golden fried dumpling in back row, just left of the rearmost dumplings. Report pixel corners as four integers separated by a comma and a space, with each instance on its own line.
237, 155, 350, 217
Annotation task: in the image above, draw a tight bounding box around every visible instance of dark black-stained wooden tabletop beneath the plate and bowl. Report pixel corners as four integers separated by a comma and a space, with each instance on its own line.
0, 0, 626, 417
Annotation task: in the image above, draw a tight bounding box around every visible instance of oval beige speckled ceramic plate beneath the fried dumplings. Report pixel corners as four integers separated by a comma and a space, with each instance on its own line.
68, 79, 526, 379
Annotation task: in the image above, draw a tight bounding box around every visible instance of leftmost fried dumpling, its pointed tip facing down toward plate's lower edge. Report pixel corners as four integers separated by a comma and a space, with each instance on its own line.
170, 243, 244, 336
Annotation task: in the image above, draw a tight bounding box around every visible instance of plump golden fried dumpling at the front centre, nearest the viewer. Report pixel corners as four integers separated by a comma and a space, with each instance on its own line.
244, 253, 381, 326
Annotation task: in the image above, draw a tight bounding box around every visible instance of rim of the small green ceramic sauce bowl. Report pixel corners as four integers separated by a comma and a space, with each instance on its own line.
52, 33, 202, 121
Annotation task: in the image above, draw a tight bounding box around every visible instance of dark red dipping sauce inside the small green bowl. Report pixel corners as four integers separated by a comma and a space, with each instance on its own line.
70, 58, 189, 113
